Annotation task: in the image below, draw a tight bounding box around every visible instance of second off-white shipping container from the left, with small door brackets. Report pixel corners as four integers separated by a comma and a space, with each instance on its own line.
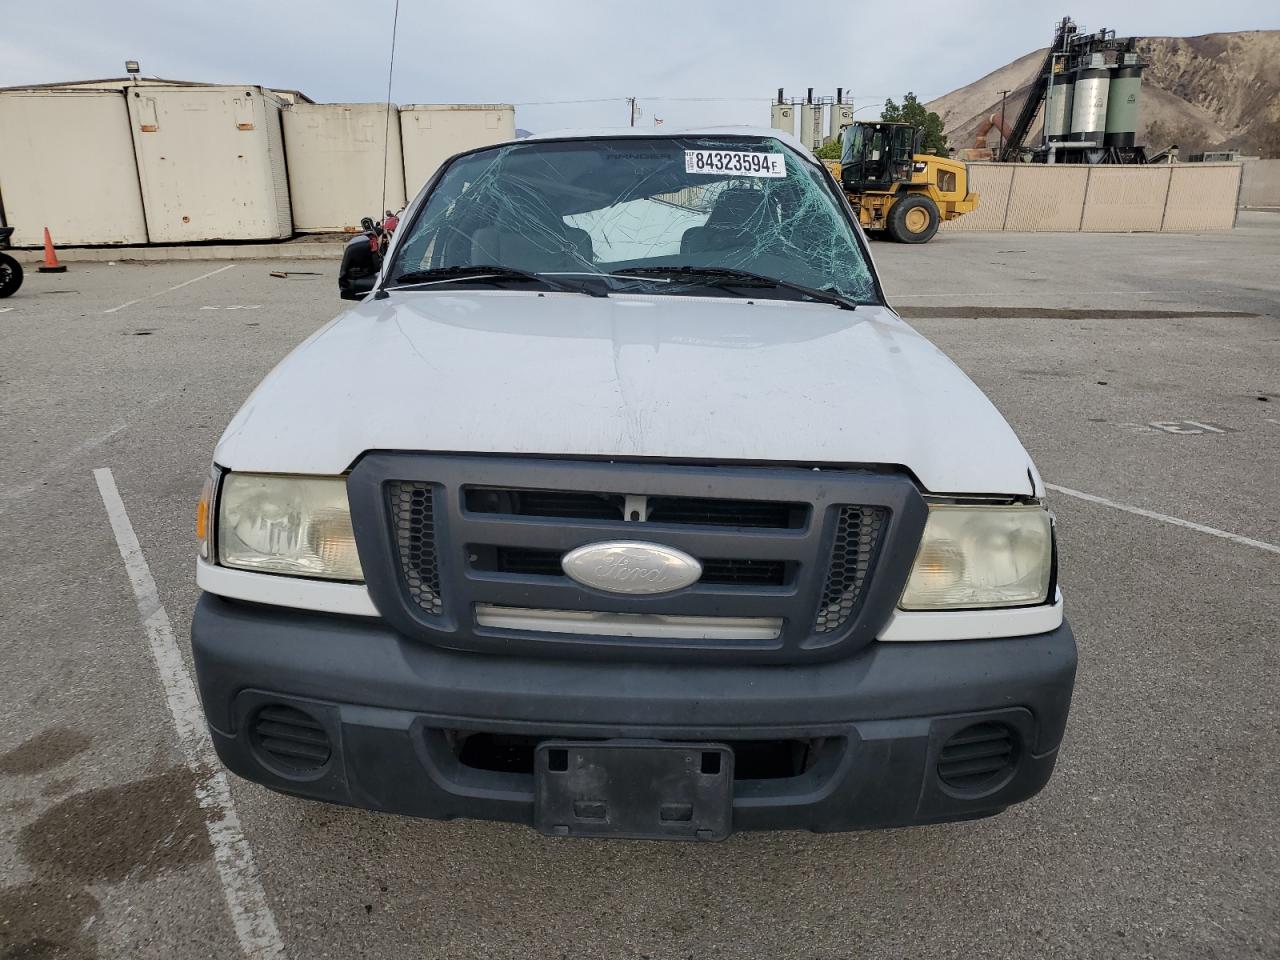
125, 86, 293, 243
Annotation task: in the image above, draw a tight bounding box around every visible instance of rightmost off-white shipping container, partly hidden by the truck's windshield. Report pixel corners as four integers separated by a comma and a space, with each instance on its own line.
401, 104, 516, 197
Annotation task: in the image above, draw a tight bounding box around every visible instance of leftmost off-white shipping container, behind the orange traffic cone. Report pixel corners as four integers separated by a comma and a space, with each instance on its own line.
0, 90, 147, 247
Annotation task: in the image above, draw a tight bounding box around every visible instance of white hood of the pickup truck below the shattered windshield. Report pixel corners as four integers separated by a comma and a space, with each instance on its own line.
215, 291, 1041, 494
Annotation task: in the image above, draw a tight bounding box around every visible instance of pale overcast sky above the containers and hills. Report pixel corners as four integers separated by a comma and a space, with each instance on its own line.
0, 0, 1280, 131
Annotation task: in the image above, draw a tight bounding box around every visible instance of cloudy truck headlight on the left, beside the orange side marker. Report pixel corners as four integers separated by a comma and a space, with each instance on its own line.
218, 474, 364, 580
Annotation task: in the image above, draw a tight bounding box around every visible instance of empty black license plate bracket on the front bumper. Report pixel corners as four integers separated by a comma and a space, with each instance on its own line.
534, 740, 733, 840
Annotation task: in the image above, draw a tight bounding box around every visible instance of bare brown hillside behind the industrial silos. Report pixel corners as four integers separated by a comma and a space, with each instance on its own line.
927, 29, 1280, 156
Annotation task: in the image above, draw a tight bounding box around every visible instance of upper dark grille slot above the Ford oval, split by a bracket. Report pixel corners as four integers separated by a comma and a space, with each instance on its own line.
465, 486, 809, 530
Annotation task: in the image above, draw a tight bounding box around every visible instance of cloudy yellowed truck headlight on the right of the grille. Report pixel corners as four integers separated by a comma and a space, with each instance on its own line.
899, 504, 1053, 611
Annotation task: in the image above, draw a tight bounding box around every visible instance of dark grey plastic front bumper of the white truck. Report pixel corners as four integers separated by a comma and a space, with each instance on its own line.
192, 594, 1075, 831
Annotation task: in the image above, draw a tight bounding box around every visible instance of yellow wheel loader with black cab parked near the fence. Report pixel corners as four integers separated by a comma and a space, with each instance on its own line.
826, 122, 978, 243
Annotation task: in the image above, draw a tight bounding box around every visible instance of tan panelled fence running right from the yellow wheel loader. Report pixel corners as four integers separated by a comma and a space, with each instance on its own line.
942, 161, 1239, 233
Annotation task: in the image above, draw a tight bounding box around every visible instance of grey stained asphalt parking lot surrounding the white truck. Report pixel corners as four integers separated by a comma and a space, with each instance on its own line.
0, 214, 1280, 960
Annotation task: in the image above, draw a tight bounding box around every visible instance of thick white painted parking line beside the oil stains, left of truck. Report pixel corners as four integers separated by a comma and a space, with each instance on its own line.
93, 467, 284, 960
